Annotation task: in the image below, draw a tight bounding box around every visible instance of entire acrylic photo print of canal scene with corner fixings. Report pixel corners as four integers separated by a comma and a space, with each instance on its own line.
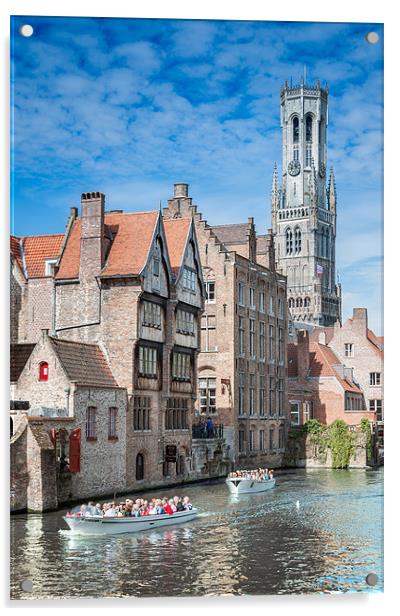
10, 16, 384, 599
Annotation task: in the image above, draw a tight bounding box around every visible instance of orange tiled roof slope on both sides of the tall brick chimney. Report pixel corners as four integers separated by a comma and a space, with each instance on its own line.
56, 211, 159, 279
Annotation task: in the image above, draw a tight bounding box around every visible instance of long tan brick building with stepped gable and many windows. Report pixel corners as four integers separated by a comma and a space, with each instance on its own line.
163, 183, 287, 466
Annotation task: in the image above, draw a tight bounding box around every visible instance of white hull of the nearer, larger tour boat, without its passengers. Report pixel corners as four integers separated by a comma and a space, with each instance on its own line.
63, 509, 197, 535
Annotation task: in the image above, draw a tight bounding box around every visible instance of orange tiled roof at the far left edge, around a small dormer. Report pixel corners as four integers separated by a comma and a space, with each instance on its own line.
10, 234, 64, 278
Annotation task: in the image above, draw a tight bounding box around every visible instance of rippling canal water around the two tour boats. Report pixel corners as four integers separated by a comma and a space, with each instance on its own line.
11, 470, 383, 599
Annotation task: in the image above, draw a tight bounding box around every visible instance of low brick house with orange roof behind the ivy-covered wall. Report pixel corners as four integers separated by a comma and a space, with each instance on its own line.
288, 330, 374, 426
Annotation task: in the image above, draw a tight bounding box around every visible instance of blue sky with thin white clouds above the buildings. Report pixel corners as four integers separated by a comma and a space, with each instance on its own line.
11, 17, 383, 334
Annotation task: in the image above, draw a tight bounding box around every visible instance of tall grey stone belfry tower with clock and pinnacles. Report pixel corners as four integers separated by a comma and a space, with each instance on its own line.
271, 80, 341, 326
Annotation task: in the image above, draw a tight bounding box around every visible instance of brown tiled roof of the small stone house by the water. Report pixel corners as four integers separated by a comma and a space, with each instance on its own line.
49, 338, 118, 387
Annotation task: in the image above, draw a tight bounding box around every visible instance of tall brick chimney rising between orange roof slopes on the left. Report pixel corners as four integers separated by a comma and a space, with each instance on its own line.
79, 192, 105, 280
